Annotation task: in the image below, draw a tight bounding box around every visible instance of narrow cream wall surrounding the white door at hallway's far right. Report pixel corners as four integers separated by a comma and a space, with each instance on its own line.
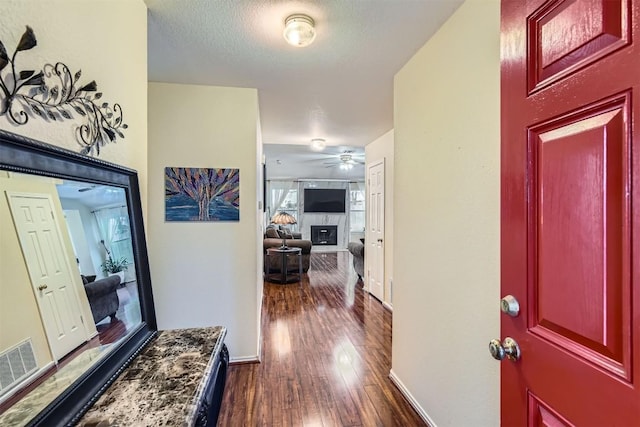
364, 129, 394, 307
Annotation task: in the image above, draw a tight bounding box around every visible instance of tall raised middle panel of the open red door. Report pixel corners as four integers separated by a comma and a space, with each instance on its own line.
528, 95, 631, 380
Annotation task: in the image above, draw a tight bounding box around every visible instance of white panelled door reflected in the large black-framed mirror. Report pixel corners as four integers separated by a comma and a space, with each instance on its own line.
8, 193, 87, 361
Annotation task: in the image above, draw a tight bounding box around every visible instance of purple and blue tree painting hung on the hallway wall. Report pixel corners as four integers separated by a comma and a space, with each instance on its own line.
164, 168, 240, 221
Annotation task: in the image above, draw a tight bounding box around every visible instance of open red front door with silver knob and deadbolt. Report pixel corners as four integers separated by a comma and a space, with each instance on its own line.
501, 0, 640, 427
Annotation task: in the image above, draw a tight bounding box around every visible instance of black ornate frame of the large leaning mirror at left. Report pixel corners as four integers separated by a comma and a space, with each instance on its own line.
0, 130, 157, 426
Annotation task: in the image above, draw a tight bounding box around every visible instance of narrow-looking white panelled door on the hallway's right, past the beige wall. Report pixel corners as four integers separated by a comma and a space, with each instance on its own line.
365, 161, 384, 301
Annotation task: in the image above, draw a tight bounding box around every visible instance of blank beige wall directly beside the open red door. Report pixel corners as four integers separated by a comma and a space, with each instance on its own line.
392, 0, 500, 427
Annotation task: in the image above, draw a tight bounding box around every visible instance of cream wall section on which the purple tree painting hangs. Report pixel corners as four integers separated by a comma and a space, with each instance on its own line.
147, 83, 261, 360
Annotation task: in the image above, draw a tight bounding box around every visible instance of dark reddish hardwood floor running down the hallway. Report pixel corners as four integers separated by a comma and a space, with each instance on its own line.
218, 252, 426, 427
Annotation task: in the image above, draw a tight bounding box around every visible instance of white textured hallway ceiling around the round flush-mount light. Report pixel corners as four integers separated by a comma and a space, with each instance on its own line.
145, 0, 462, 177
